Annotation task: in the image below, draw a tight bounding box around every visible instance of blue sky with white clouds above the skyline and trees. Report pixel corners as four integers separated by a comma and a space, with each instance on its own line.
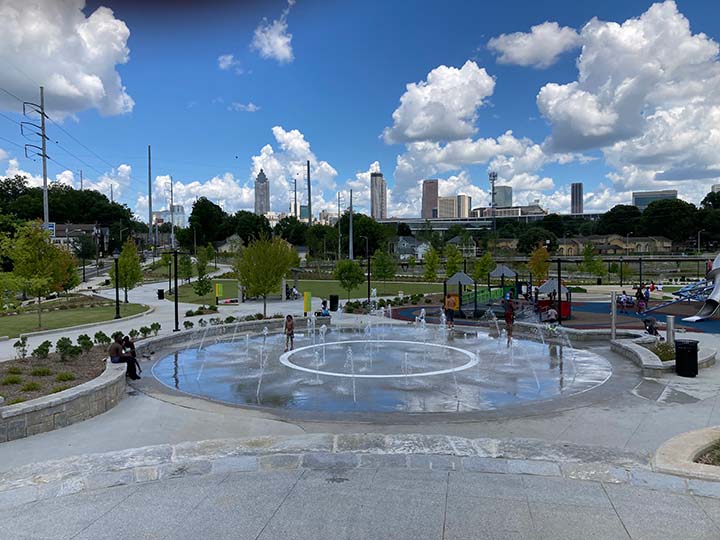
0, 0, 720, 218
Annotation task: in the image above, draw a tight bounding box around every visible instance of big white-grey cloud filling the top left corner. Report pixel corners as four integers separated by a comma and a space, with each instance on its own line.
0, 0, 134, 117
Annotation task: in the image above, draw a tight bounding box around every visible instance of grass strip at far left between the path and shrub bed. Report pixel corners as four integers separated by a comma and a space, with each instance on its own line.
0, 304, 147, 338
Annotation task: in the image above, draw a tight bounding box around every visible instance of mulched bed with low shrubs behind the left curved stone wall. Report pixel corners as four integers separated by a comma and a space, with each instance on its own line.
0, 346, 107, 405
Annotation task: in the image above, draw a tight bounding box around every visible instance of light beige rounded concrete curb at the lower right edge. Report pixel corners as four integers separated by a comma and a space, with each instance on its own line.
653, 426, 720, 480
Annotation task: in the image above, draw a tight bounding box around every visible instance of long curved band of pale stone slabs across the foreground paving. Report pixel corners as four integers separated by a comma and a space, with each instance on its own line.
0, 433, 660, 508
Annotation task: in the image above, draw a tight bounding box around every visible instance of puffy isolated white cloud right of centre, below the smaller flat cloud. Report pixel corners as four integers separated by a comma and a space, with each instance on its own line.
383, 60, 495, 144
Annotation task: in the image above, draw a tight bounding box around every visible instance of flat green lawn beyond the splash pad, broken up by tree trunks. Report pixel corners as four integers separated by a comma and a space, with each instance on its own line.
172, 279, 442, 304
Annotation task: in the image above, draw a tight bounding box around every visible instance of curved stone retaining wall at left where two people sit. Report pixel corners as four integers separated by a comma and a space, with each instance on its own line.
0, 360, 125, 442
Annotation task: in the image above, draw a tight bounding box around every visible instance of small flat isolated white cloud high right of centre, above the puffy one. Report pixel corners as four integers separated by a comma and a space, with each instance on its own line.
488, 21, 580, 68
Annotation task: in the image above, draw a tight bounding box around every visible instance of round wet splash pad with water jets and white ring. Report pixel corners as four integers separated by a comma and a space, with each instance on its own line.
153, 310, 612, 413
